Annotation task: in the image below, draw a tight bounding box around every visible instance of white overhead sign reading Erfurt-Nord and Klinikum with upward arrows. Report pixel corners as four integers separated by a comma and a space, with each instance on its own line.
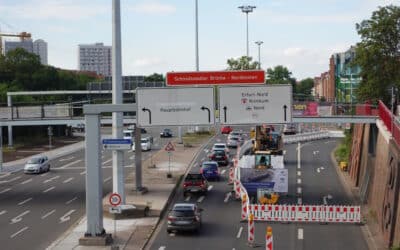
219, 84, 292, 124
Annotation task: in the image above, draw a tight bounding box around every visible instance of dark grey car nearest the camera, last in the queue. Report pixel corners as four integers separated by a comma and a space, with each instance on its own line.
167, 203, 203, 233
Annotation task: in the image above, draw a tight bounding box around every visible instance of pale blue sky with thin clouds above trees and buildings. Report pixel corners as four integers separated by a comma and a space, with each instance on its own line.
0, 0, 400, 80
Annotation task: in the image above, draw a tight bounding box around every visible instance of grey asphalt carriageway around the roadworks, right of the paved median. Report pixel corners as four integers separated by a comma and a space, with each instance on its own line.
147, 131, 368, 250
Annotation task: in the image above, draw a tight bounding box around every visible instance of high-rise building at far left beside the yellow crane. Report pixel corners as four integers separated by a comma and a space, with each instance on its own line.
4, 39, 47, 65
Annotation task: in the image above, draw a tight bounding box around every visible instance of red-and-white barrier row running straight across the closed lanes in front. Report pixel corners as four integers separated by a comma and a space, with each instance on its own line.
248, 204, 361, 223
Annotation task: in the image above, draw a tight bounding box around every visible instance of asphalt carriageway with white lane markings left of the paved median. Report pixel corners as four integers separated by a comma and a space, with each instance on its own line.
0, 130, 172, 249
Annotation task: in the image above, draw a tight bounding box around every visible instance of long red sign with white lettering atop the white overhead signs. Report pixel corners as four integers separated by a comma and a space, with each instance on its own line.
167, 70, 265, 86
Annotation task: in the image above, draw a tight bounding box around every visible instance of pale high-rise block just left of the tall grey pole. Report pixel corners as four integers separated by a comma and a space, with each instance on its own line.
78, 43, 112, 76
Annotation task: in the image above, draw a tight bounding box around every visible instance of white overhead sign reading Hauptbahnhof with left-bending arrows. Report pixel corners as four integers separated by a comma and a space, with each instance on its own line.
136, 87, 215, 127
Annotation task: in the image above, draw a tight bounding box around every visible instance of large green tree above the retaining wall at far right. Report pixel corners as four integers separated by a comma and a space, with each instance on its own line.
354, 5, 400, 103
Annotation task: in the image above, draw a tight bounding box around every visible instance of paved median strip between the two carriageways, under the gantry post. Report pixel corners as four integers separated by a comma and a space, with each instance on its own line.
47, 135, 212, 250
